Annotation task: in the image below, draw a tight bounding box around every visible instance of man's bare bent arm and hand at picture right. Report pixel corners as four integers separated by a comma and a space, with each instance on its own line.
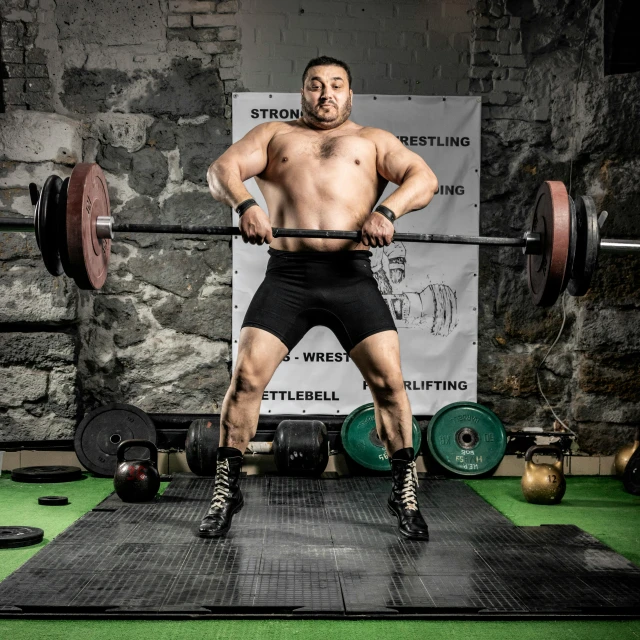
362, 129, 438, 247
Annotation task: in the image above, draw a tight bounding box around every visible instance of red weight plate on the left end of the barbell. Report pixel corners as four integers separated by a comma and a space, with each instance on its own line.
66, 163, 111, 289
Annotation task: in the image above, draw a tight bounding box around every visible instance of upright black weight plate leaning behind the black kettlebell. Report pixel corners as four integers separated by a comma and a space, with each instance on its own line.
73, 402, 156, 476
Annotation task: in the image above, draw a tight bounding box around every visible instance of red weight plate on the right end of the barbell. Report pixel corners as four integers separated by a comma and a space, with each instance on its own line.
527, 180, 571, 307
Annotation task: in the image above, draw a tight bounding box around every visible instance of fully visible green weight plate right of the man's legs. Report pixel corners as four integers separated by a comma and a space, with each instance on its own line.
427, 402, 507, 476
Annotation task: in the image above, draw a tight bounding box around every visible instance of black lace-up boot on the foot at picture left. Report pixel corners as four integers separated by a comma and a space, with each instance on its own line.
198, 447, 244, 538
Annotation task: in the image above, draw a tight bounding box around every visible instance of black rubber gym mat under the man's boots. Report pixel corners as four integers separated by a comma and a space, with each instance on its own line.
0, 474, 640, 618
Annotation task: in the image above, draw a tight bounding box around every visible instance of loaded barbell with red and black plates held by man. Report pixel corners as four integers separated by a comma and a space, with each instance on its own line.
0, 163, 640, 307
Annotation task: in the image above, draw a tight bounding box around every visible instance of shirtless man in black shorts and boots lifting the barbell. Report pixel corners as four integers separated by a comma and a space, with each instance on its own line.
199, 57, 438, 540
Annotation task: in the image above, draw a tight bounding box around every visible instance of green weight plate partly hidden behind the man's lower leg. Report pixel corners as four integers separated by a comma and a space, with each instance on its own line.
342, 402, 422, 471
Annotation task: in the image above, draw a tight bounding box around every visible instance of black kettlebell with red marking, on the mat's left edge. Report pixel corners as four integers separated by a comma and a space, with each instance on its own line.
113, 440, 160, 502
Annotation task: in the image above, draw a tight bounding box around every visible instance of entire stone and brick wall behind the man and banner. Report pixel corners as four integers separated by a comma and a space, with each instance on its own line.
0, 0, 640, 454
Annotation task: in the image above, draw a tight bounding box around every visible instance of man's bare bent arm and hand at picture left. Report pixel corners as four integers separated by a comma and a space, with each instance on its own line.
207, 122, 280, 244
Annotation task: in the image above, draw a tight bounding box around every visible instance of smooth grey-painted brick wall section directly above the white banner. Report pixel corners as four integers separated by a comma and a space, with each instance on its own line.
238, 0, 473, 95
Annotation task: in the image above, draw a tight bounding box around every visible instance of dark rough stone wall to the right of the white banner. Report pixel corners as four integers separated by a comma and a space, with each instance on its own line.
470, 0, 640, 453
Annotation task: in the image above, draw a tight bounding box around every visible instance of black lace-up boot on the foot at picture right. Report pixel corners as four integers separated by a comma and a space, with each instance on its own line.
387, 447, 429, 540
